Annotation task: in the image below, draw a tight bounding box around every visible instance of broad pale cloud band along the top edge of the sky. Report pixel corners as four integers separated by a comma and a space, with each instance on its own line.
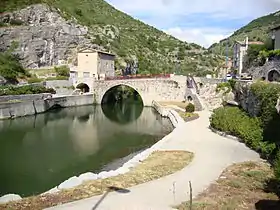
107, 0, 280, 18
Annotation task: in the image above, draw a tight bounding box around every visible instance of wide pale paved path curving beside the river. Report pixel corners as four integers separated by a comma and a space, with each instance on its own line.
47, 111, 259, 210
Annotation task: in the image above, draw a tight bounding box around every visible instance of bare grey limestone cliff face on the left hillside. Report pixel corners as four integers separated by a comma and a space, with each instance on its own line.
0, 4, 101, 68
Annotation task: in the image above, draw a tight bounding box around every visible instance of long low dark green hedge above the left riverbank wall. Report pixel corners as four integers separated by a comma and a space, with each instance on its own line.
0, 85, 55, 96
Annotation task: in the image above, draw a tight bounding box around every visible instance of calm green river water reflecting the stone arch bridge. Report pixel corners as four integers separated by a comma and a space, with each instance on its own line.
0, 104, 173, 197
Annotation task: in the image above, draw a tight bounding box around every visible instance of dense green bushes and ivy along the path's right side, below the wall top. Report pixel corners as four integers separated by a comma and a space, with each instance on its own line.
210, 82, 280, 185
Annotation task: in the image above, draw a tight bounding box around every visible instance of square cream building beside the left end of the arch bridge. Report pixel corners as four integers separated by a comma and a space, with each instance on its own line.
70, 49, 115, 80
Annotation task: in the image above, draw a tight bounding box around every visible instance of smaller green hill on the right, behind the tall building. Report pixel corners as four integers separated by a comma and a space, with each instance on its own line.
209, 11, 280, 55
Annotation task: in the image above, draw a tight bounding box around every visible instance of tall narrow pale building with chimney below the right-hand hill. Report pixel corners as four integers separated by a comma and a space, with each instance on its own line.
233, 37, 264, 75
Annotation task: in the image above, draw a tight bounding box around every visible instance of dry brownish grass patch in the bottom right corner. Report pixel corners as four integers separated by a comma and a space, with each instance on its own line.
177, 162, 280, 210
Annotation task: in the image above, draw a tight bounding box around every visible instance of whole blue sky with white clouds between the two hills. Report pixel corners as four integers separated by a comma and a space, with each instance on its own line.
106, 0, 280, 47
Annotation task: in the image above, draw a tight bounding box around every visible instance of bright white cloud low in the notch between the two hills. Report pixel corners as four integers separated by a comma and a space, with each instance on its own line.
165, 27, 232, 48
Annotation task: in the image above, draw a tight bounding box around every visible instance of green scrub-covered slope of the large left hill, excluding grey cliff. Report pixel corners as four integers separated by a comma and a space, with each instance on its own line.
0, 0, 224, 76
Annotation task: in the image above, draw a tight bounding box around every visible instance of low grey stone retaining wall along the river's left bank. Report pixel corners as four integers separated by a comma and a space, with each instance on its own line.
0, 94, 93, 119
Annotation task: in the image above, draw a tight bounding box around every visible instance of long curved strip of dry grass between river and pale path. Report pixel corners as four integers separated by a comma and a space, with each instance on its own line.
0, 151, 193, 209
